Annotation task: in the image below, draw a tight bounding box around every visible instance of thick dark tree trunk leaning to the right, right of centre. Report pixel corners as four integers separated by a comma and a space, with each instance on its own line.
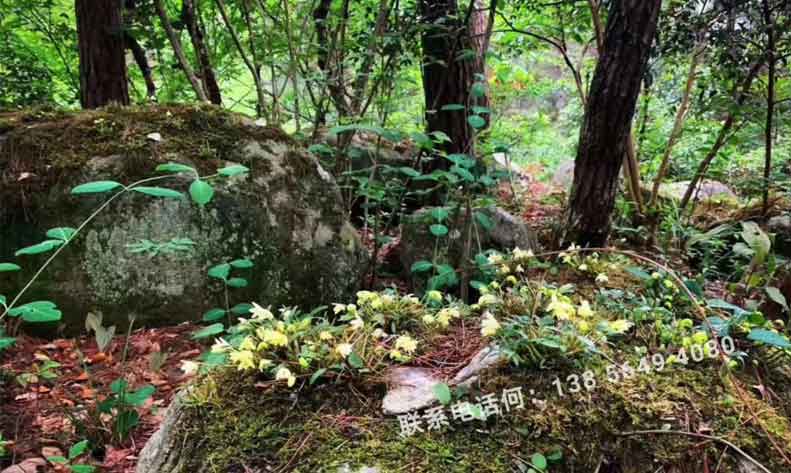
561, 0, 662, 246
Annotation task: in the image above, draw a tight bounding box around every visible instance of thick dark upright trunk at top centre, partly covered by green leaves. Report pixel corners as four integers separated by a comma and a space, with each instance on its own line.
420, 0, 482, 159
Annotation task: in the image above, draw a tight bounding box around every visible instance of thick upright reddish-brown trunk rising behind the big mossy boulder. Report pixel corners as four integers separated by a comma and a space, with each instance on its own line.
74, 0, 129, 108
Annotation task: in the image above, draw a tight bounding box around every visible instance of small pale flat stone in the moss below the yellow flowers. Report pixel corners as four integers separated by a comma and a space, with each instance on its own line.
382, 366, 442, 415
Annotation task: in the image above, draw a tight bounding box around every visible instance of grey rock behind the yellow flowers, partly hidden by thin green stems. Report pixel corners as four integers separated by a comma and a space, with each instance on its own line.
401, 207, 538, 286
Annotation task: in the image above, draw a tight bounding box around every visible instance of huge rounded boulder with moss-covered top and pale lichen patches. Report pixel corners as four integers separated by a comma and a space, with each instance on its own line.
0, 106, 365, 328
